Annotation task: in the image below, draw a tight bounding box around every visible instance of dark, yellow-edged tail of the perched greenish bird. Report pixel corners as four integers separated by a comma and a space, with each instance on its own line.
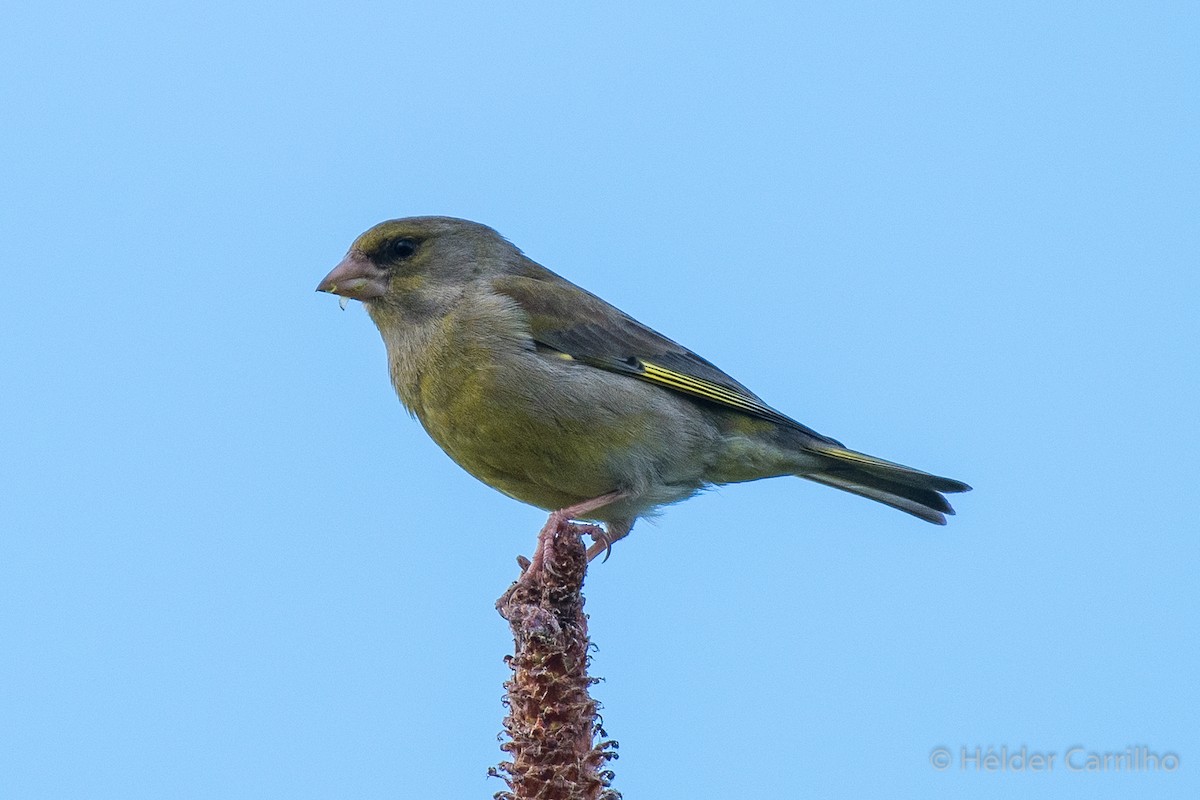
799, 443, 971, 525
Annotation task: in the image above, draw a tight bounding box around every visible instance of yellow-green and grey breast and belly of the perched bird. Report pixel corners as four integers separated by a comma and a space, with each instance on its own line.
391, 325, 709, 509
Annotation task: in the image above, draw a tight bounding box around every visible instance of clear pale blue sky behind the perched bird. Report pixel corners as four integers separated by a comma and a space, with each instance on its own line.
0, 2, 1200, 799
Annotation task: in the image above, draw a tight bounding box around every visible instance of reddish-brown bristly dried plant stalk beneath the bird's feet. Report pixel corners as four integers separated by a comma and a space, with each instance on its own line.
492, 517, 620, 800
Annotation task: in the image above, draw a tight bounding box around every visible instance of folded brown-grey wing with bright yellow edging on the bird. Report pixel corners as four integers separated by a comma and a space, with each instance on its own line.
493, 272, 838, 444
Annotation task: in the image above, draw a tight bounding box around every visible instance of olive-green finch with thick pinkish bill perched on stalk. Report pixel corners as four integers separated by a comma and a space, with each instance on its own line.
317, 216, 971, 561
